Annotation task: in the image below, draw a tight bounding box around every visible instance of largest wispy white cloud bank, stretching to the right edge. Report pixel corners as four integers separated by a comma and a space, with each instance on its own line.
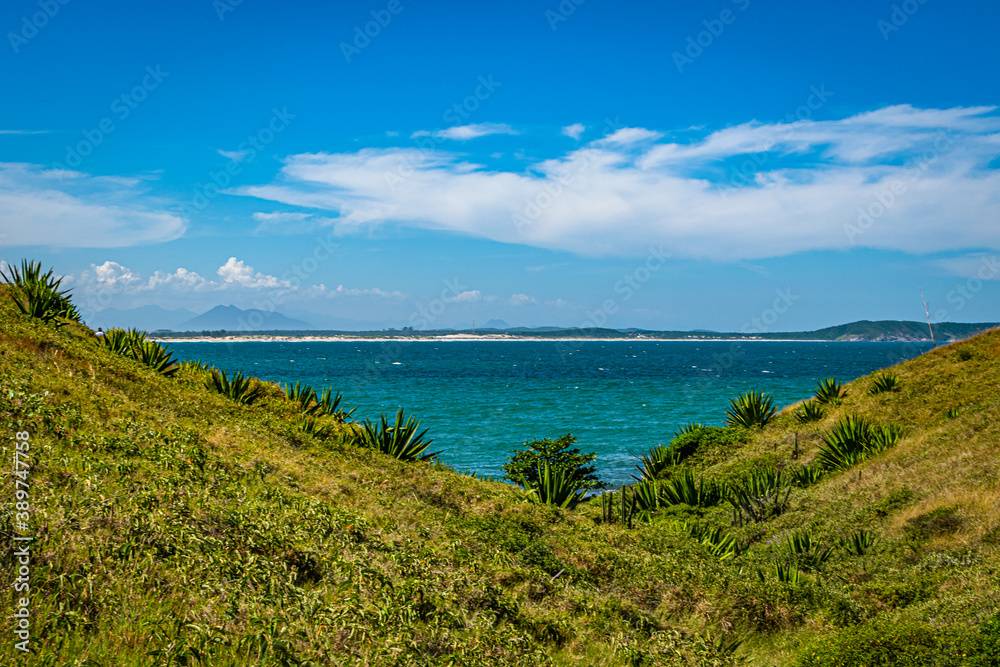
239, 106, 1000, 261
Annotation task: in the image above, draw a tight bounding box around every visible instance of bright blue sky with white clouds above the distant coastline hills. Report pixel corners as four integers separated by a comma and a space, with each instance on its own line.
0, 0, 1000, 331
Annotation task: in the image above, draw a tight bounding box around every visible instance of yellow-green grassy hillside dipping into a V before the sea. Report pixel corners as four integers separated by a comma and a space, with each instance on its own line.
0, 294, 1000, 666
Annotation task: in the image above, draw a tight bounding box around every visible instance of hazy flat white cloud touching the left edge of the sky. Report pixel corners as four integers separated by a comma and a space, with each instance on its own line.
0, 163, 185, 248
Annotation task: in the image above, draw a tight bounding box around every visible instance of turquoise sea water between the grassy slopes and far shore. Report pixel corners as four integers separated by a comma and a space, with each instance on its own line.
164, 341, 930, 485
